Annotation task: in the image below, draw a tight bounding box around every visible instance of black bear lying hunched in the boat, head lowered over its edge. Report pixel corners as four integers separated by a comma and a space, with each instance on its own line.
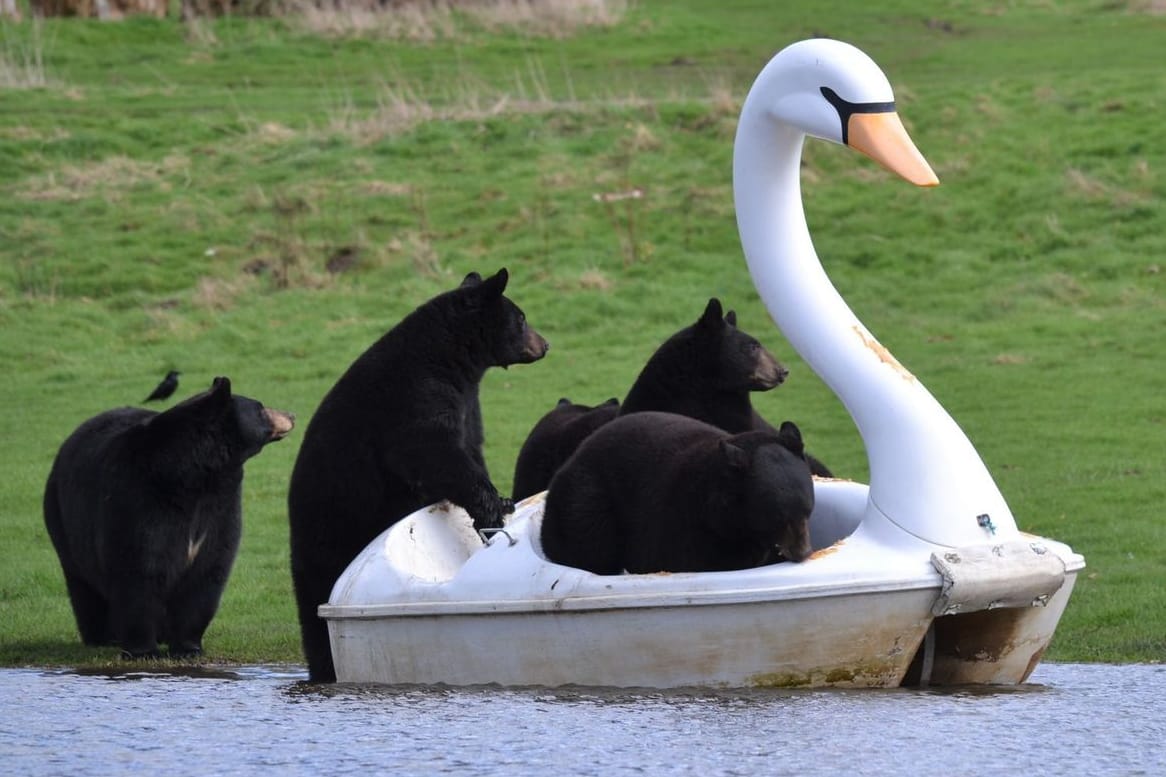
540, 412, 814, 575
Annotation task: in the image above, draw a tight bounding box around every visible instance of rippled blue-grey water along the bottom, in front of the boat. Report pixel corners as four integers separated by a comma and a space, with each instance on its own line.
0, 664, 1166, 777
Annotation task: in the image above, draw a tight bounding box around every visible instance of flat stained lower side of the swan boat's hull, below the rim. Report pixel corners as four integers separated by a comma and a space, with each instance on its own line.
331, 590, 934, 687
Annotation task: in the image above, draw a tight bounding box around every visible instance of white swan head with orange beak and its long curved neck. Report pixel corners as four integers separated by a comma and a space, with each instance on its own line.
733, 40, 1016, 545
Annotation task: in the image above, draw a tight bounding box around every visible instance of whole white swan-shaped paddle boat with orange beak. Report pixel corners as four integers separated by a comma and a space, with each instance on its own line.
319, 40, 1084, 688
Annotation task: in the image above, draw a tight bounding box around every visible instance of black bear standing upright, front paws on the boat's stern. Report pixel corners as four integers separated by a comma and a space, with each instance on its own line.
288, 268, 548, 683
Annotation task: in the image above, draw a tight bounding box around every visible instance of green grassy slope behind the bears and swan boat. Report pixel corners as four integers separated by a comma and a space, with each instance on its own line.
0, 0, 1166, 665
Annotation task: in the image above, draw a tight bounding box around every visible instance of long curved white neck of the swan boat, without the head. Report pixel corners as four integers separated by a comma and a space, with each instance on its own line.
733, 92, 1017, 546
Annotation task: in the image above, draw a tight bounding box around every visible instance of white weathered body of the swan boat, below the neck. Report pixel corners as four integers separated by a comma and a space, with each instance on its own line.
319, 482, 1083, 688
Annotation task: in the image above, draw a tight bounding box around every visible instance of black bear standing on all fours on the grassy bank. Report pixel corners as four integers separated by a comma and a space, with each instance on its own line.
44, 378, 295, 658
